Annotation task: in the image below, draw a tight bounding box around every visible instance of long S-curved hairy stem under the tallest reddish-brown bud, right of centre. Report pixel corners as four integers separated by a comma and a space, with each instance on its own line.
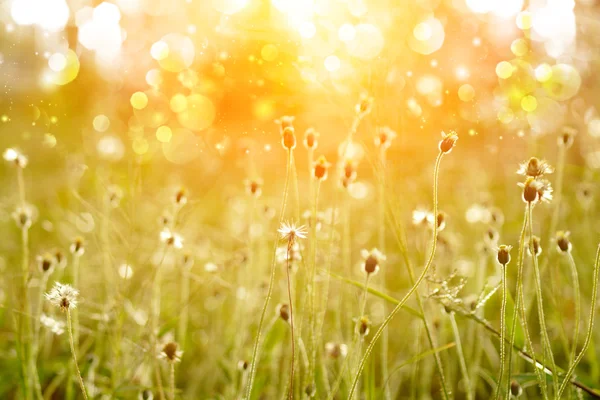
348, 151, 449, 399
